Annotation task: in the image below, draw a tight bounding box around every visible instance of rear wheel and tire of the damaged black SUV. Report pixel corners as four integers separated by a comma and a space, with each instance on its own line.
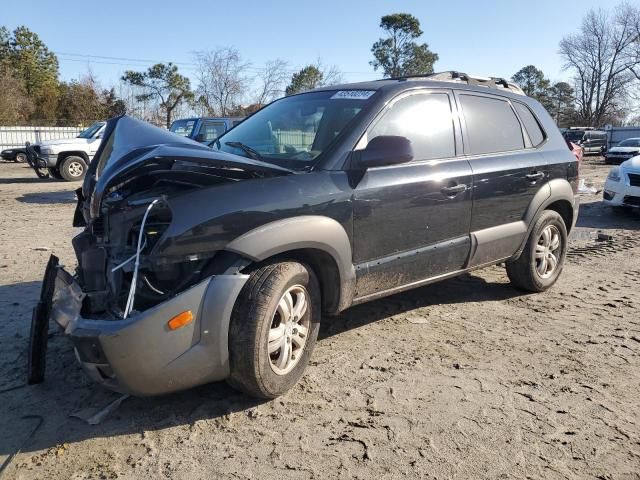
506, 210, 567, 292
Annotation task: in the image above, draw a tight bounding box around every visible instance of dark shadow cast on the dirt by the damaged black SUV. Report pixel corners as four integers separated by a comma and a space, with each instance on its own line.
0, 275, 520, 462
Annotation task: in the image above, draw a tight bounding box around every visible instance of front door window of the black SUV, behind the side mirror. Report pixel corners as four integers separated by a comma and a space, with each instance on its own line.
367, 93, 456, 160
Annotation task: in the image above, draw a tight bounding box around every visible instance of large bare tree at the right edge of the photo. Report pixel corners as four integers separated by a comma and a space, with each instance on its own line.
560, 3, 640, 126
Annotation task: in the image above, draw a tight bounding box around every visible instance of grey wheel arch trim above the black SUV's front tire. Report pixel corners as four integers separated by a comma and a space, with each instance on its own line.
225, 215, 355, 313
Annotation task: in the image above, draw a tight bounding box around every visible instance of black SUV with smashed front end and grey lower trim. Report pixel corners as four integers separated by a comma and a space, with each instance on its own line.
30, 72, 578, 398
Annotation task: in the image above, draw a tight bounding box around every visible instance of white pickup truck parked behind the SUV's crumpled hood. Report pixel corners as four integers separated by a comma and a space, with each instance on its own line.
32, 122, 106, 182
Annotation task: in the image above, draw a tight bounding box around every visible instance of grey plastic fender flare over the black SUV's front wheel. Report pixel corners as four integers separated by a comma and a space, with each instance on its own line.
225, 215, 356, 313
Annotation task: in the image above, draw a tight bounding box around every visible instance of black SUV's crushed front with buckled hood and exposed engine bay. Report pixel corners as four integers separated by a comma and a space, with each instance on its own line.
73, 117, 291, 319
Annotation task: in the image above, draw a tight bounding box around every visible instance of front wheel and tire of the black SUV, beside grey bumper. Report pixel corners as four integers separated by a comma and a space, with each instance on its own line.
227, 261, 321, 399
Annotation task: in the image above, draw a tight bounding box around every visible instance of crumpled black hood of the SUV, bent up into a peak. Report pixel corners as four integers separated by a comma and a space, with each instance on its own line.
82, 116, 292, 220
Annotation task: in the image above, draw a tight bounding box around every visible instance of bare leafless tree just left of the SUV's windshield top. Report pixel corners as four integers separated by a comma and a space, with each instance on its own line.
195, 47, 251, 116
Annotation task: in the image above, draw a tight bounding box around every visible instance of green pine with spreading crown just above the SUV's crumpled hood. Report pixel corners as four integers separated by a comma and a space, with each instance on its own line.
122, 62, 194, 128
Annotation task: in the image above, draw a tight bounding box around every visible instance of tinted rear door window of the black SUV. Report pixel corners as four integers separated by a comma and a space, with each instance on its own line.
460, 94, 524, 155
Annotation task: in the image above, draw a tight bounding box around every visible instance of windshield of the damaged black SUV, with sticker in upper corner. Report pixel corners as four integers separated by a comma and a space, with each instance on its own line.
213, 90, 375, 169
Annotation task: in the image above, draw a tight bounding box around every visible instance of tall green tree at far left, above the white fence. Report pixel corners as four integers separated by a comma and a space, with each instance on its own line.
5, 26, 59, 120
